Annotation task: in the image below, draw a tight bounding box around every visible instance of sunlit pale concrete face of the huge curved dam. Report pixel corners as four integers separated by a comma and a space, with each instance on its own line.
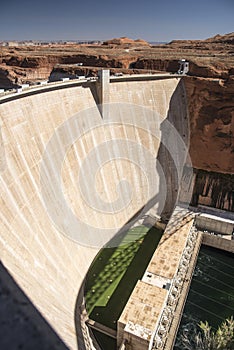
0, 78, 187, 349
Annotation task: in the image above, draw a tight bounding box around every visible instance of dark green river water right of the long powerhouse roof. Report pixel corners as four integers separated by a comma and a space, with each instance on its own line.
174, 246, 234, 350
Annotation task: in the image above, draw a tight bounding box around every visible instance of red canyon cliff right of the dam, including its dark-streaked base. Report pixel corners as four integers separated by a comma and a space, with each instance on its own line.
180, 76, 234, 212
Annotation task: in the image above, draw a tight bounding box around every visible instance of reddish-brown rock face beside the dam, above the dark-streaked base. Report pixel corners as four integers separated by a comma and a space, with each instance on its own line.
185, 77, 234, 174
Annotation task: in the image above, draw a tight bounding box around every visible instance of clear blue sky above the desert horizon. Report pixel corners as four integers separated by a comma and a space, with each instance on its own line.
0, 0, 234, 42
